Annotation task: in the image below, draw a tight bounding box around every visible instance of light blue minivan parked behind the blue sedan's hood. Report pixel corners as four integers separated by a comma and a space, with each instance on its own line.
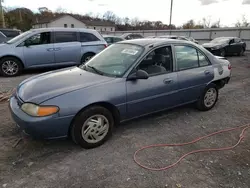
0, 28, 107, 76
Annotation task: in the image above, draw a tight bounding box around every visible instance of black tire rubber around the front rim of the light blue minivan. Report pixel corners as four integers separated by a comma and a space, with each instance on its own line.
0, 57, 23, 77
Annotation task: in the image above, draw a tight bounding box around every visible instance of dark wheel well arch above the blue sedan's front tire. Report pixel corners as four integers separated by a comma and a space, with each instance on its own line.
68, 102, 120, 135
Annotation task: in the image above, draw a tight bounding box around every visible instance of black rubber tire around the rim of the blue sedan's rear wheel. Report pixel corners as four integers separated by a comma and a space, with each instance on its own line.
196, 84, 219, 111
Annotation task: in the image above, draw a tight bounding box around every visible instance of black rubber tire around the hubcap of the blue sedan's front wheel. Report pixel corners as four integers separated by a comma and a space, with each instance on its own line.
70, 106, 114, 149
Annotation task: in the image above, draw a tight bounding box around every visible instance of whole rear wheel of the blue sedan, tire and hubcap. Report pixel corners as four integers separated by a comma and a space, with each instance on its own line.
197, 84, 219, 111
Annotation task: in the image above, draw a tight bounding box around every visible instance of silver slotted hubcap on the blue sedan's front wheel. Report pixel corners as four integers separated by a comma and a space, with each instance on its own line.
82, 115, 109, 143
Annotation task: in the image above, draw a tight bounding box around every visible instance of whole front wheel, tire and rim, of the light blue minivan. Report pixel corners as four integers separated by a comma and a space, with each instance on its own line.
0, 57, 23, 77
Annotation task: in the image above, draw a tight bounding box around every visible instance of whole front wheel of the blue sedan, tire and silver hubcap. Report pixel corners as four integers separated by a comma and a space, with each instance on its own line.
71, 106, 114, 149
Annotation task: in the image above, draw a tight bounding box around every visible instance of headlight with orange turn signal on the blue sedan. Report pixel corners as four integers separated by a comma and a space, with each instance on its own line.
21, 103, 59, 117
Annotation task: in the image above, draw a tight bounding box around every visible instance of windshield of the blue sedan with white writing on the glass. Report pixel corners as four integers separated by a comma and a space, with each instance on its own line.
83, 43, 144, 77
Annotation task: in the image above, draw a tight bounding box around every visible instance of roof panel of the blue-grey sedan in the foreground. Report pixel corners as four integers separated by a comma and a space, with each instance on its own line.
118, 38, 193, 47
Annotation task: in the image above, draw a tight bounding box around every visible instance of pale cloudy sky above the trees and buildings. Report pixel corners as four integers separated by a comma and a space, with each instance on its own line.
3, 0, 250, 26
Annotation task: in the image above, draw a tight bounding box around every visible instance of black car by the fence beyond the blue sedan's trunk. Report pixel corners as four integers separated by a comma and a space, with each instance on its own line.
203, 37, 246, 57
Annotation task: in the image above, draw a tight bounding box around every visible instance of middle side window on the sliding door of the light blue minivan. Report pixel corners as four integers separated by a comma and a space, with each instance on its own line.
54, 31, 77, 43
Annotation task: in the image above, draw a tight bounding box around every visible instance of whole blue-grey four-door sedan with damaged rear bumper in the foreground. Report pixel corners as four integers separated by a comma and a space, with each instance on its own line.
10, 39, 231, 148
